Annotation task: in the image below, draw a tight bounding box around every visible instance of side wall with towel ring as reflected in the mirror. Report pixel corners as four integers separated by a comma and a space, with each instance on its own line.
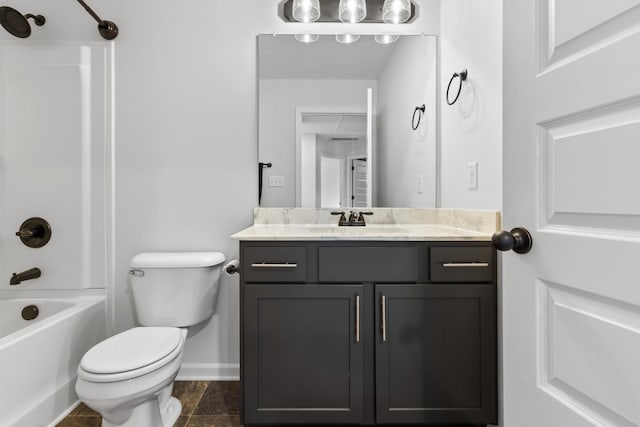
376, 37, 437, 207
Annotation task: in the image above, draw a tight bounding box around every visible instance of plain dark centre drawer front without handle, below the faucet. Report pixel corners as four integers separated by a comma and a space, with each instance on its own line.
318, 246, 418, 283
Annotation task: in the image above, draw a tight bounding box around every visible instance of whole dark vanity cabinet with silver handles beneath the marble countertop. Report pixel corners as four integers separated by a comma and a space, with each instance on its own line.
240, 241, 497, 426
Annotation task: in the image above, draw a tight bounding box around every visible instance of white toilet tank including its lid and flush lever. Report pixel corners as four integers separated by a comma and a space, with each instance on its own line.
129, 252, 224, 327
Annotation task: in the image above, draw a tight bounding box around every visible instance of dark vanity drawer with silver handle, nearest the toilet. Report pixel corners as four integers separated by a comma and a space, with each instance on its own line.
242, 246, 307, 283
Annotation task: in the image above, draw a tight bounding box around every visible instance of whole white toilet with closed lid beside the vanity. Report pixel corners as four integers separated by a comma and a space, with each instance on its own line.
76, 252, 224, 427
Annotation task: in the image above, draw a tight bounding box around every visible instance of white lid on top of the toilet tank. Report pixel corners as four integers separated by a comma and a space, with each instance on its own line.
129, 252, 224, 268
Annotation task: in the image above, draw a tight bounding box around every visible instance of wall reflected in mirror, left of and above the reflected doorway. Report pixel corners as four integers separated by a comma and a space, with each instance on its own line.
259, 79, 376, 207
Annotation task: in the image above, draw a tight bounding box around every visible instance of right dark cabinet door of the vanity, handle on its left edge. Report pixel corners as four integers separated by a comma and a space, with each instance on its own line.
376, 284, 497, 424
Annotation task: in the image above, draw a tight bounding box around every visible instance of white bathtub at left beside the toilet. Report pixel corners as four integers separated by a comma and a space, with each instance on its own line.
0, 291, 105, 427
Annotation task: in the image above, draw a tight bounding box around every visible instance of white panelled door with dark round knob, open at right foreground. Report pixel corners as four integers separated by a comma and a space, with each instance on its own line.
502, 0, 640, 427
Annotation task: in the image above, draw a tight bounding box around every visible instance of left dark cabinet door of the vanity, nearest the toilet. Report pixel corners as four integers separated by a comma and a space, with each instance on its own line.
242, 285, 363, 424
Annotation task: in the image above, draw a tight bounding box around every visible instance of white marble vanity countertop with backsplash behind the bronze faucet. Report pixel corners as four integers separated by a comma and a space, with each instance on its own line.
231, 208, 501, 241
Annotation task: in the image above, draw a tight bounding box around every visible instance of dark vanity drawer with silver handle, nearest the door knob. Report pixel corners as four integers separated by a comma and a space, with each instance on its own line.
430, 246, 495, 283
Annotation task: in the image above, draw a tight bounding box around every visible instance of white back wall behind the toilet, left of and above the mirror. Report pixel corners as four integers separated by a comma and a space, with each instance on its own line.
0, 0, 440, 377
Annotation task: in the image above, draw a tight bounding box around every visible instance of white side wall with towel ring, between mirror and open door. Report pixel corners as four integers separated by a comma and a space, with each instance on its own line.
440, 0, 508, 210
